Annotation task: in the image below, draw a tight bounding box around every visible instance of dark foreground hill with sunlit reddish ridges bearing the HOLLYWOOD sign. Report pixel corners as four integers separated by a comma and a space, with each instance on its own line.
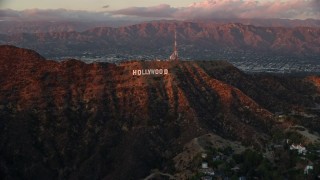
0, 45, 320, 179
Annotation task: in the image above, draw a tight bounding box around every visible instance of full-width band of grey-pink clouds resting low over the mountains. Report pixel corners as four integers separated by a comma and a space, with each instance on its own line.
0, 0, 320, 21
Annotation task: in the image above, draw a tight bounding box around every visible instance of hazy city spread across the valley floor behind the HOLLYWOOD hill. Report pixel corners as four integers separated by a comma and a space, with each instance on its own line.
49, 45, 320, 74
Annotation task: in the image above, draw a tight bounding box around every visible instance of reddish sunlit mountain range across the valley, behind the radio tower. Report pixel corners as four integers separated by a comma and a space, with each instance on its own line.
0, 21, 320, 57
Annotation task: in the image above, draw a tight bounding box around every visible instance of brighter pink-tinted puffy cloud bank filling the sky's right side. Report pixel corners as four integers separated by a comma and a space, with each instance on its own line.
110, 0, 320, 19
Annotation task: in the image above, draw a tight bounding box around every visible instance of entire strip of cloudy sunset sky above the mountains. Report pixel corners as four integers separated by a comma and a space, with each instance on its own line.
0, 0, 320, 21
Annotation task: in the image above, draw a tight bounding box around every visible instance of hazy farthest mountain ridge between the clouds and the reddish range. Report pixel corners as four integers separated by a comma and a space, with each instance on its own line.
0, 19, 320, 34
